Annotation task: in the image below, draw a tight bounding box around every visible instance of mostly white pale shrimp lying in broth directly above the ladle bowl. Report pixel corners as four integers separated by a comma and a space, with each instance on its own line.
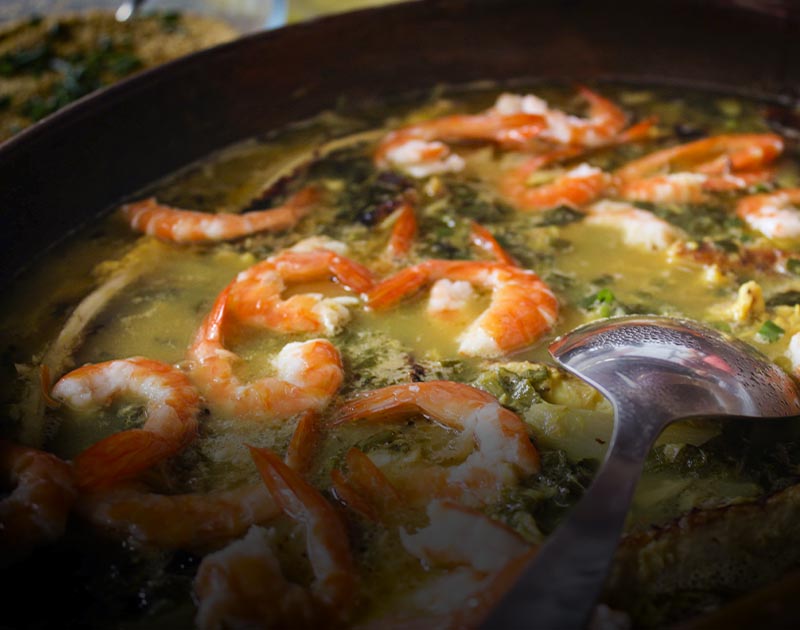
585, 201, 686, 251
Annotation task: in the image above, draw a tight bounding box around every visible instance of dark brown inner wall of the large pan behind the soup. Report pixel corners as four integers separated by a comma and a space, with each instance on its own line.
0, 0, 800, 628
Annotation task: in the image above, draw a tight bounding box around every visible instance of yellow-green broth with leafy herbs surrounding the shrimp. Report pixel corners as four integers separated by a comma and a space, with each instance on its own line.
0, 85, 800, 628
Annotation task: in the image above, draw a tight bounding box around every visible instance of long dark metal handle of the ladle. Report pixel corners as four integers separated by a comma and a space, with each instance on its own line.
483, 418, 658, 630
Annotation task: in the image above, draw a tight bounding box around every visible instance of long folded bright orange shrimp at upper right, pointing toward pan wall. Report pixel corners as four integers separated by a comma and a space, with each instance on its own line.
614, 133, 783, 203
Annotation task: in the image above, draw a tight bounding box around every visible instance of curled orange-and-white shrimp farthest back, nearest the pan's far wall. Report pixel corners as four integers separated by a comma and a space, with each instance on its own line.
491, 86, 632, 147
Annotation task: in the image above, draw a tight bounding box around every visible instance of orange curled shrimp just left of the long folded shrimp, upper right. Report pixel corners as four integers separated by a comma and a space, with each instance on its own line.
500, 156, 611, 210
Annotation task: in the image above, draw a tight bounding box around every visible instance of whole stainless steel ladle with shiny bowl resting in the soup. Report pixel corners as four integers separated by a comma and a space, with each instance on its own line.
483, 317, 800, 630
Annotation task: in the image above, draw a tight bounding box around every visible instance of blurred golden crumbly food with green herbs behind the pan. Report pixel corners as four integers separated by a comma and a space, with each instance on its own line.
0, 9, 238, 140
